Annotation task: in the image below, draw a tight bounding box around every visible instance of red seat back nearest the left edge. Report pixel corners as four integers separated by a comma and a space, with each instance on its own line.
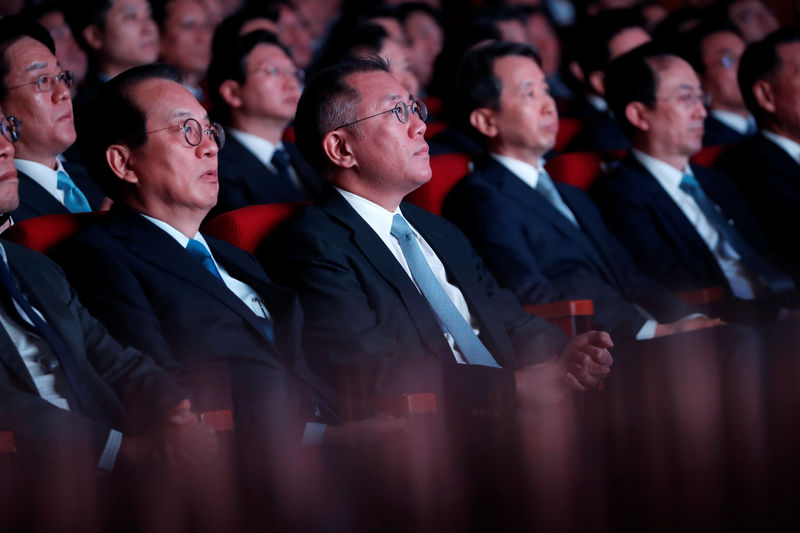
3, 211, 106, 254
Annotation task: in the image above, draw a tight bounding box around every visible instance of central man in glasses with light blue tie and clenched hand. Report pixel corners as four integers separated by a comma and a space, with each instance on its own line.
262, 58, 611, 412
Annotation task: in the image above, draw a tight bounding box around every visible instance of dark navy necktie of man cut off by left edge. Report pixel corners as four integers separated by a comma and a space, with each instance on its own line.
0, 254, 108, 422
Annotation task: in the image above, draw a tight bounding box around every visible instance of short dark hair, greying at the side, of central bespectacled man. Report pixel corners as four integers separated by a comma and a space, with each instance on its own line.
294, 57, 389, 174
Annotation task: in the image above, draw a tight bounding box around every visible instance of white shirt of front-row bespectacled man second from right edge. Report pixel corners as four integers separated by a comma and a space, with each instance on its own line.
631, 148, 756, 300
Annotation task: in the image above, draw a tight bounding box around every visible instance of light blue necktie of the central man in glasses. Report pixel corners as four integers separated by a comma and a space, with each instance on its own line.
391, 214, 500, 368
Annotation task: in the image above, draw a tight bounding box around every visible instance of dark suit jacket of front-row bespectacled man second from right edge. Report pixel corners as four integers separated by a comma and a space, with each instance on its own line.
590, 154, 768, 291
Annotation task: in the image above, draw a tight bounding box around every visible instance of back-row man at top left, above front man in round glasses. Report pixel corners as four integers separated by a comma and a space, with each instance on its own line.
65, 0, 158, 112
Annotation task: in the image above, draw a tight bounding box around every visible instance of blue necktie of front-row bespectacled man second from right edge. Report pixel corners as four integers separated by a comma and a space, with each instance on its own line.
679, 174, 794, 294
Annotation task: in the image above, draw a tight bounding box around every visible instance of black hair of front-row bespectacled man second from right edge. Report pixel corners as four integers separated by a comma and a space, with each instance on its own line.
605, 41, 680, 137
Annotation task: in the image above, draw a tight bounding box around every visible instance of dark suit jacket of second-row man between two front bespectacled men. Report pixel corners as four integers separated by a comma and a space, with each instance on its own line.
209, 135, 323, 218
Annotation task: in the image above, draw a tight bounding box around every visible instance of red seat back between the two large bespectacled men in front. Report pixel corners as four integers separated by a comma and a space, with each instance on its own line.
200, 202, 308, 253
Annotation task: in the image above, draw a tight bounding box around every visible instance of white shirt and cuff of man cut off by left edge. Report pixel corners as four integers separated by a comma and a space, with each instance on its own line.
0, 244, 122, 472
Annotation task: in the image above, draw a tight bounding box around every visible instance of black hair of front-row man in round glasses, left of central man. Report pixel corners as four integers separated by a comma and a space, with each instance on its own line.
78, 63, 181, 200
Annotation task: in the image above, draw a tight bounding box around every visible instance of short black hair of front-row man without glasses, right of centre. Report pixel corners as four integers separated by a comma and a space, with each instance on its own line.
454, 41, 542, 139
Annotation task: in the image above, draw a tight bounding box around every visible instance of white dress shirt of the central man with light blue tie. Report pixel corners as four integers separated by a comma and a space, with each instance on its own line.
336, 187, 480, 364
